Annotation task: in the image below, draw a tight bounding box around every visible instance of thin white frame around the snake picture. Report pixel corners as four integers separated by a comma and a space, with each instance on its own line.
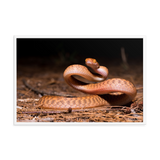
11, 32, 149, 127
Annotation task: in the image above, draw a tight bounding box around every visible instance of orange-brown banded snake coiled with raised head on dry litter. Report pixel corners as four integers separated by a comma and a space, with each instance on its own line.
36, 58, 137, 110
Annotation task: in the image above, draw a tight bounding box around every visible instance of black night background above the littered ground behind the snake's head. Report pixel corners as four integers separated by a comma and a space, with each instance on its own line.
17, 38, 143, 66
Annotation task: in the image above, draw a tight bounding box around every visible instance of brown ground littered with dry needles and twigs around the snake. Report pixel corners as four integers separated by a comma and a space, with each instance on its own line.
17, 57, 143, 122
